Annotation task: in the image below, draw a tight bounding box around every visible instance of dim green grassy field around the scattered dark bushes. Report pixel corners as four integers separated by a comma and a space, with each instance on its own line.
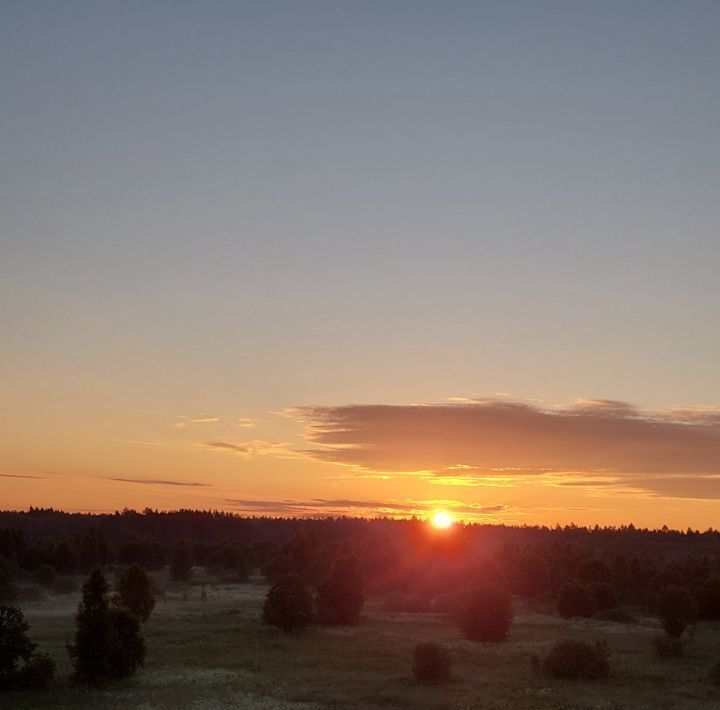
0, 582, 720, 710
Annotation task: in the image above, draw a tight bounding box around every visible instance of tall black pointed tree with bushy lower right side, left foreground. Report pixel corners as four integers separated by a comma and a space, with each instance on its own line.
68, 569, 145, 685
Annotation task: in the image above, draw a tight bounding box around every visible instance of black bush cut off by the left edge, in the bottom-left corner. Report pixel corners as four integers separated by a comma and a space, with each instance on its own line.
0, 606, 55, 690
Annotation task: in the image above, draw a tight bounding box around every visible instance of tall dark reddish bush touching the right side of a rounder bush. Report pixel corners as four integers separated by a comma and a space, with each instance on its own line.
317, 557, 365, 626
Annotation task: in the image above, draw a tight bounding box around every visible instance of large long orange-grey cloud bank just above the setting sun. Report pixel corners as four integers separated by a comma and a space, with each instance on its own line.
290, 400, 720, 499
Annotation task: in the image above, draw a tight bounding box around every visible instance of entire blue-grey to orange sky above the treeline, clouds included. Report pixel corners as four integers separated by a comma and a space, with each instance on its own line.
0, 0, 720, 528
